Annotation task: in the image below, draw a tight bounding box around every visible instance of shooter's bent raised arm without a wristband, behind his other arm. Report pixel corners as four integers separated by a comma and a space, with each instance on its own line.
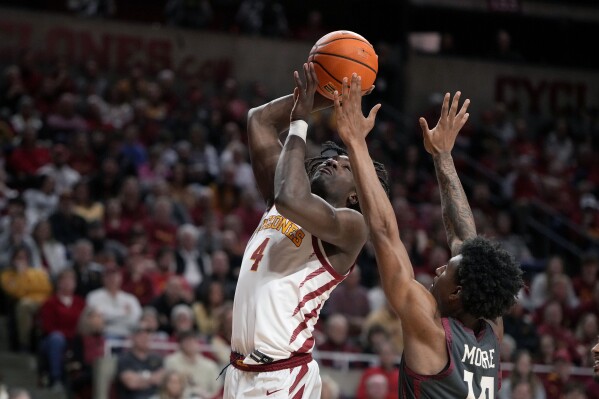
247, 70, 332, 208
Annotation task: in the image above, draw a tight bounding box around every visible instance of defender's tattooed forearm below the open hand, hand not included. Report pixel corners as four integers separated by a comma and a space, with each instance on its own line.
434, 154, 476, 256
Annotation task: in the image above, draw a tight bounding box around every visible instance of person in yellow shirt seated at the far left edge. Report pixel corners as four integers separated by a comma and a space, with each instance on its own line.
0, 246, 52, 350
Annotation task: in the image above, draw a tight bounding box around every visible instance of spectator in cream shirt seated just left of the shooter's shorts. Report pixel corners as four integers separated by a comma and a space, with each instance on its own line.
164, 331, 222, 398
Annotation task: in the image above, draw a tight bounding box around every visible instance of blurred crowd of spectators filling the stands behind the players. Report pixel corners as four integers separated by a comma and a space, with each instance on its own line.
0, 18, 599, 399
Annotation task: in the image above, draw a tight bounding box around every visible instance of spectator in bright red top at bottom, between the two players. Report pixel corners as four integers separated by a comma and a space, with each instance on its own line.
356, 342, 399, 399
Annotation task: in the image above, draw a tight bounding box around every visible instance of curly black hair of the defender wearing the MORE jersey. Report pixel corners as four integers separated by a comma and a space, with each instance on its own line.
456, 236, 524, 319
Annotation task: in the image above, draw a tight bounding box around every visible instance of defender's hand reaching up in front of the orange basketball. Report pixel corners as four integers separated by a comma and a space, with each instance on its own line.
334, 73, 381, 144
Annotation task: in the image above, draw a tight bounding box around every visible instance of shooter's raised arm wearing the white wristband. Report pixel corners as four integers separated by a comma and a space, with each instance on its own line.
275, 63, 367, 272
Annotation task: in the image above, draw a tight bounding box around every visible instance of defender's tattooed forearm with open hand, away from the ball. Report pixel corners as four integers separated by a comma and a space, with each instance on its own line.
420, 91, 476, 256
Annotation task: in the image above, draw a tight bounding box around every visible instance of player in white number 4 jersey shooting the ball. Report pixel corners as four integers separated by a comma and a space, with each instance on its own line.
224, 64, 388, 399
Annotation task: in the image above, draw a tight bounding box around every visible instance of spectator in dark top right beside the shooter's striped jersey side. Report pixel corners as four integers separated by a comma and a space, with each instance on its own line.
324, 265, 370, 338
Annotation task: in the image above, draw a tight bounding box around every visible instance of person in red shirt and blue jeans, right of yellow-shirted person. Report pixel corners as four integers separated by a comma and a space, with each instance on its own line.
40, 269, 85, 385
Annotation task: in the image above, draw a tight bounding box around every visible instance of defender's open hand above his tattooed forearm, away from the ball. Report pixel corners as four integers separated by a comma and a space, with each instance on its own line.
419, 91, 470, 155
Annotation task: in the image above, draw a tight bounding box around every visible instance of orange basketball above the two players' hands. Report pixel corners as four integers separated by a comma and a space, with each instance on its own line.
308, 30, 379, 100
